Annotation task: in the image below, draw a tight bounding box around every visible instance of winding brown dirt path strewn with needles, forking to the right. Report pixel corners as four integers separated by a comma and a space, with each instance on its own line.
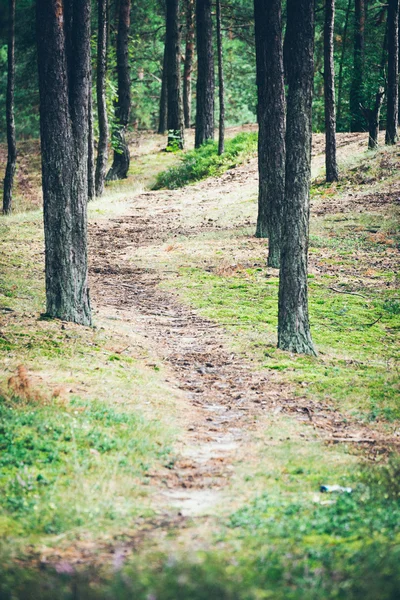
86, 135, 394, 528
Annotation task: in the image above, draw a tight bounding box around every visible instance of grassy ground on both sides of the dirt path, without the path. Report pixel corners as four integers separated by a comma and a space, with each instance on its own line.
0, 135, 400, 600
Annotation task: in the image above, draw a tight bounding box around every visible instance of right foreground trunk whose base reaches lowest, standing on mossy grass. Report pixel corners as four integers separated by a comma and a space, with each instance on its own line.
278, 0, 315, 354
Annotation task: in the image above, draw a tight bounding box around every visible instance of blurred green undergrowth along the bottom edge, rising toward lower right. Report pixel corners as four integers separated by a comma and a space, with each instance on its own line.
0, 460, 400, 600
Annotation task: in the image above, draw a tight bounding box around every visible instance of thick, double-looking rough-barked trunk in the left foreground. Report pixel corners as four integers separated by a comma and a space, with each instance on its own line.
36, 0, 91, 325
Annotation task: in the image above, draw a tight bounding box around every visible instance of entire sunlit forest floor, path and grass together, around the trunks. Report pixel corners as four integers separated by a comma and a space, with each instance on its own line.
0, 125, 400, 599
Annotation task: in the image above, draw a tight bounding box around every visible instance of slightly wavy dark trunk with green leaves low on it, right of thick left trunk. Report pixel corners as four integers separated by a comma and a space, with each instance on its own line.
107, 0, 131, 181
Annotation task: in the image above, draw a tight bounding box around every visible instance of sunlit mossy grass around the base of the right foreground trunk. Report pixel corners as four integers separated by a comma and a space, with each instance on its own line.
164, 268, 400, 420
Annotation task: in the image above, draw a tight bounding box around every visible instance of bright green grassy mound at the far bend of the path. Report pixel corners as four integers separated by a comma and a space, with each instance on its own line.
154, 133, 258, 190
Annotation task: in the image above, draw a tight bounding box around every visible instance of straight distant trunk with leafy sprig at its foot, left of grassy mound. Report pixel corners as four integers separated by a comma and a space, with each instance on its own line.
165, 0, 184, 149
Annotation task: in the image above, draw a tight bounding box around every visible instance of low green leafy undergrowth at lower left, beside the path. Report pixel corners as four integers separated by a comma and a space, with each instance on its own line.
0, 396, 168, 539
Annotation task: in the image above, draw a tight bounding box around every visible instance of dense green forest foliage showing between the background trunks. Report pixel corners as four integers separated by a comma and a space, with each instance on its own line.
0, 0, 396, 140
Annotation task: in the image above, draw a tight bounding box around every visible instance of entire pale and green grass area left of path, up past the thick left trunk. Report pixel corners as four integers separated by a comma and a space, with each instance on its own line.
0, 207, 174, 553
